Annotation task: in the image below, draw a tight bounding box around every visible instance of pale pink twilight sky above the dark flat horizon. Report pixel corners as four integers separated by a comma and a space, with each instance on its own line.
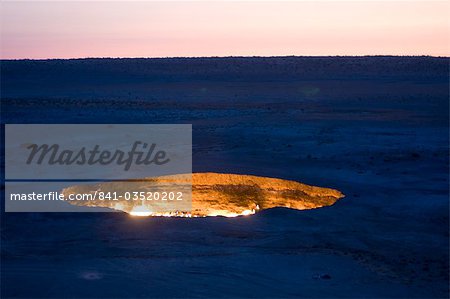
0, 1, 450, 59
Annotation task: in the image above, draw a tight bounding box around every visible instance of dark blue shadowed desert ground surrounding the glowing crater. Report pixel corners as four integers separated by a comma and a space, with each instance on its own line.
1, 57, 449, 298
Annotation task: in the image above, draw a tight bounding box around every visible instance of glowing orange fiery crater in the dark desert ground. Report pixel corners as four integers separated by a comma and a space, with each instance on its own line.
62, 172, 344, 217
